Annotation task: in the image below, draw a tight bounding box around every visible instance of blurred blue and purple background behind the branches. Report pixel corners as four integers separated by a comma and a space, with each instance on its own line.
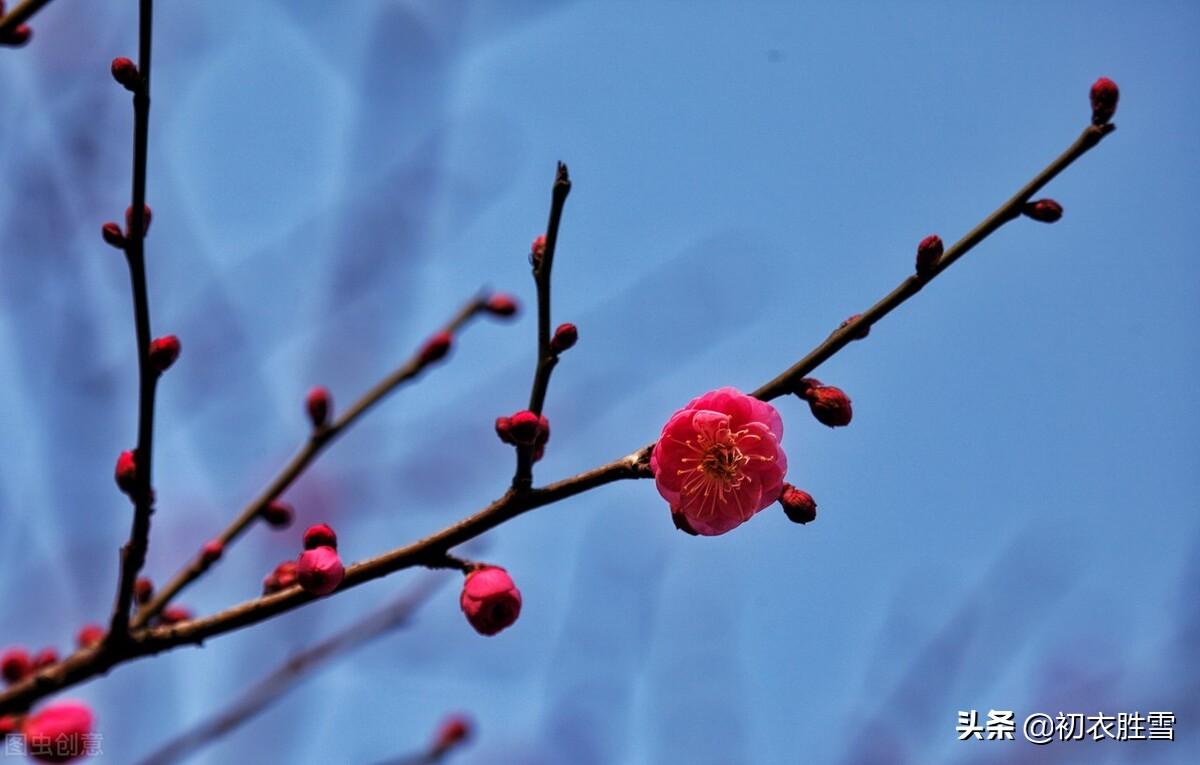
0, 0, 1200, 765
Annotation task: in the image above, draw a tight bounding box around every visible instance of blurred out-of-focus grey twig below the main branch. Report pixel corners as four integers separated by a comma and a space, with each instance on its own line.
135, 574, 444, 765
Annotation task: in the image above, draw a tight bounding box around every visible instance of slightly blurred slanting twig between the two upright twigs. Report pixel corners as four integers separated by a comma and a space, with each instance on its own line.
133, 293, 487, 630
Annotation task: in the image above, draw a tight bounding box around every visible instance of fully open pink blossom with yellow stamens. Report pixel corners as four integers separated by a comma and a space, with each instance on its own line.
650, 387, 787, 536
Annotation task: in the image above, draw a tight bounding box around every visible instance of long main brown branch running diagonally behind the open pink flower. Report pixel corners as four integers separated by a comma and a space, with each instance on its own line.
0, 116, 1112, 715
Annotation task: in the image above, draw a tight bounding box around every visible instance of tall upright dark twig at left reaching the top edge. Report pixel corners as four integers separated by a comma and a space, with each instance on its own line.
106, 0, 158, 646
